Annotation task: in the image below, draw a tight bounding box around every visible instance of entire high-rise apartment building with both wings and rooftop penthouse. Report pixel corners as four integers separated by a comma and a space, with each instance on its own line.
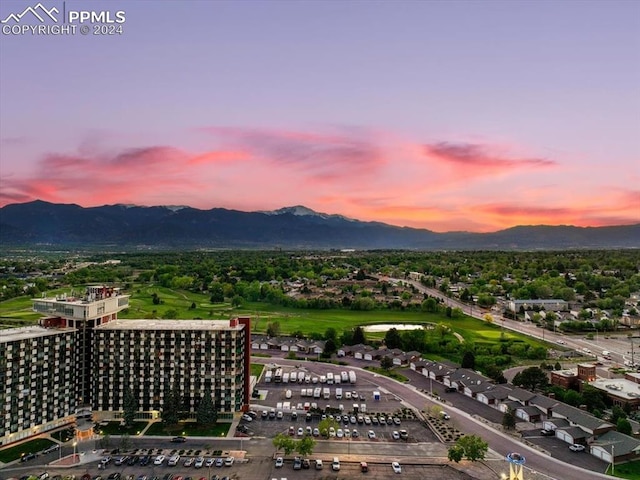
0, 286, 251, 445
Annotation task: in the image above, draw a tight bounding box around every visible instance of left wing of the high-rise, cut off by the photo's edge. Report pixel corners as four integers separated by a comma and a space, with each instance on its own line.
0, 326, 77, 445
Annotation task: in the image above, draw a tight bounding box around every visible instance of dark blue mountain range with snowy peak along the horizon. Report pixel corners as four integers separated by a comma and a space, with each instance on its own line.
0, 200, 640, 250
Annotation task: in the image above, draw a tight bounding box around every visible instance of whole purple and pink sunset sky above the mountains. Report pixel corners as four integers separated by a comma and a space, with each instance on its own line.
0, 0, 640, 232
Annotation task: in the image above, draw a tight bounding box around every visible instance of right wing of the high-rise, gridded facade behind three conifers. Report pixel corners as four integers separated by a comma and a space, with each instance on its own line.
92, 319, 250, 418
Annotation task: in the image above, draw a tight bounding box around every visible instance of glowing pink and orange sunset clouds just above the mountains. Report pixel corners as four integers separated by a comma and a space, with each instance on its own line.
1, 127, 640, 231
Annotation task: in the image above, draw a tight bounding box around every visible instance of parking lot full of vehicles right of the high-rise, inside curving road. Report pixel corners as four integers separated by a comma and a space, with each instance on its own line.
240, 364, 438, 442
